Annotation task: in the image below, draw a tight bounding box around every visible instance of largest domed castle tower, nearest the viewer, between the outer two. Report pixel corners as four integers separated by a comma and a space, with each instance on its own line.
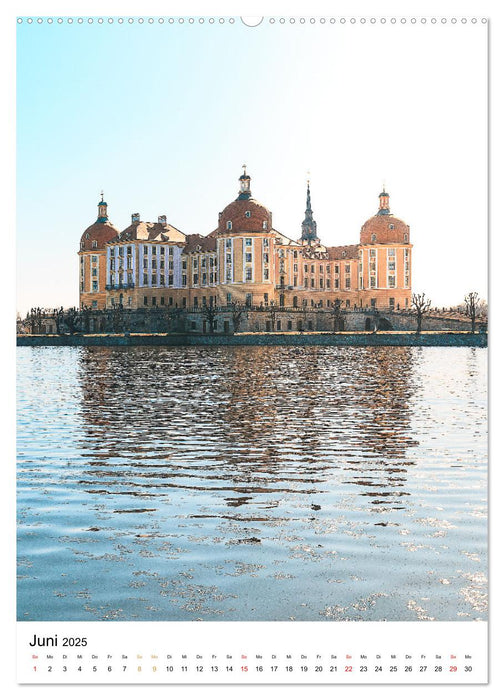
216, 165, 275, 306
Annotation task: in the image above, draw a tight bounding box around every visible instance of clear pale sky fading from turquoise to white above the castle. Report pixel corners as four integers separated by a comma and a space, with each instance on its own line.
17, 15, 487, 313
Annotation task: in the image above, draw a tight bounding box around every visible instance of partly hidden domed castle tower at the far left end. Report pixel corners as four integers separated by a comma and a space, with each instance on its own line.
79, 192, 119, 309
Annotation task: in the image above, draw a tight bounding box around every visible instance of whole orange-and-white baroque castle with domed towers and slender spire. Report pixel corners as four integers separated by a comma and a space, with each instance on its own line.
79, 171, 412, 324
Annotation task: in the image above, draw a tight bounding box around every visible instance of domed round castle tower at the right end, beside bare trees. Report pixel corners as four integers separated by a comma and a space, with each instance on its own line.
359, 185, 412, 310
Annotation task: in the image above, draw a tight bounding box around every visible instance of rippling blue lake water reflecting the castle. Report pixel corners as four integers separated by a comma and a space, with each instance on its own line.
18, 347, 487, 621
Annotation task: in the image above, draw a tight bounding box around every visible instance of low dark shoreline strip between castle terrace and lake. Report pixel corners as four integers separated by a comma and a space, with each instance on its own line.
16, 331, 488, 347
